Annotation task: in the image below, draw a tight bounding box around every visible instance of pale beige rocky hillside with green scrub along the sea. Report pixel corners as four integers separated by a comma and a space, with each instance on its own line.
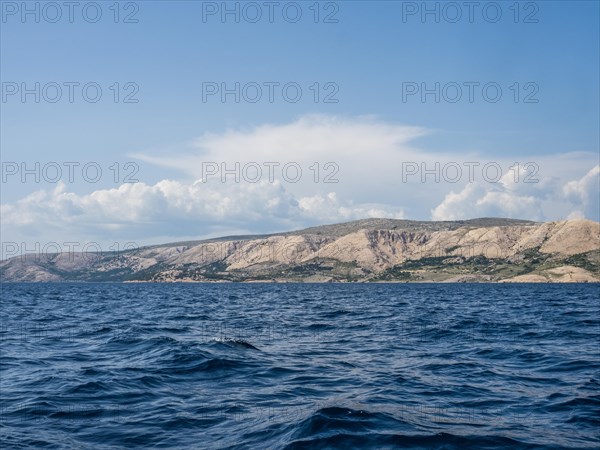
0, 218, 600, 282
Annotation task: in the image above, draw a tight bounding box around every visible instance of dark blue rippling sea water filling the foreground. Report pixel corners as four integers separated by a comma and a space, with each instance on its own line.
0, 284, 600, 449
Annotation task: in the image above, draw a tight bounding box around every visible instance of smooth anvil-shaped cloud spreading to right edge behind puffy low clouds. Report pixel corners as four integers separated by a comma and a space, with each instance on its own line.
134, 115, 597, 219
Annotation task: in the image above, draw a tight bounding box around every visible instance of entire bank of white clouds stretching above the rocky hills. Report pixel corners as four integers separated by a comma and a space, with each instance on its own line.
1, 115, 600, 251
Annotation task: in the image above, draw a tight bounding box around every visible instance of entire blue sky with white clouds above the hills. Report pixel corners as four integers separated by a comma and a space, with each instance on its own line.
0, 1, 600, 256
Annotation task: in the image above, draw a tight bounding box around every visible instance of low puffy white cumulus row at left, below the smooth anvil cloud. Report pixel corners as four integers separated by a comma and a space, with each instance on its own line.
2, 180, 402, 246
